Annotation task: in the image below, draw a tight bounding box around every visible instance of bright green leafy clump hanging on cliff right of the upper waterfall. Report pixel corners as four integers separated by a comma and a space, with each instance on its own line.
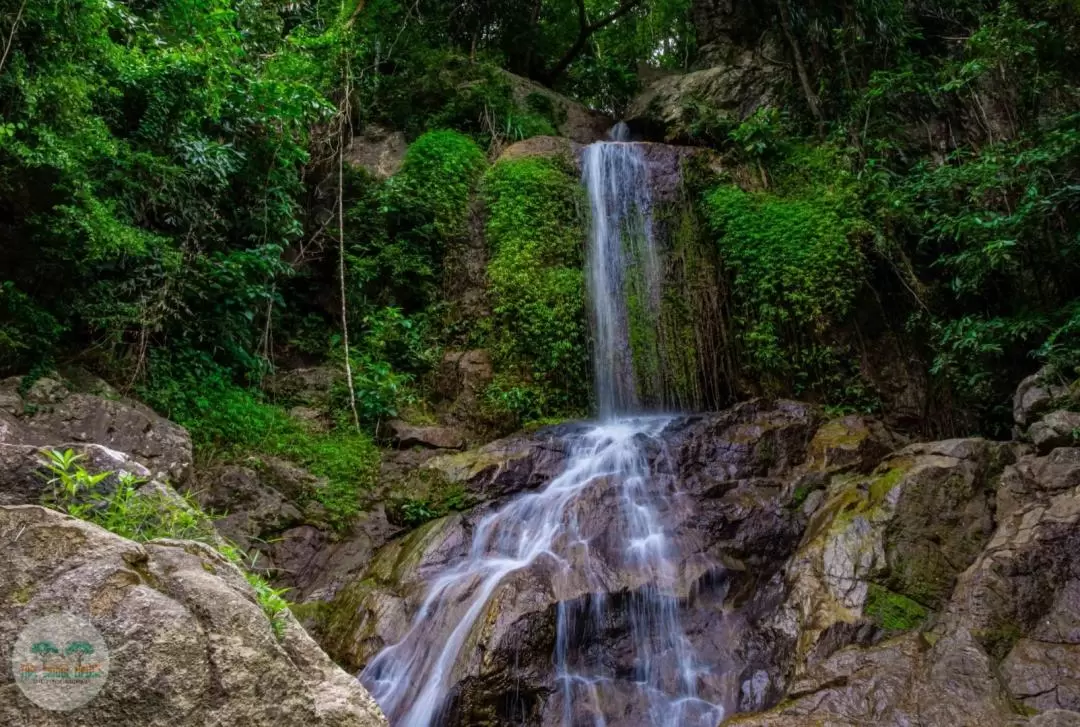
705, 146, 865, 398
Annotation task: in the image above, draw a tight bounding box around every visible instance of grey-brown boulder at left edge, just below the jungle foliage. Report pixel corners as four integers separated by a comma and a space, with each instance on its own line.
0, 377, 192, 482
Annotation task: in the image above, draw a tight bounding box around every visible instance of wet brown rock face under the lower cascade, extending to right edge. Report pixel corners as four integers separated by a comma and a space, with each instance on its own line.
319, 369, 1080, 727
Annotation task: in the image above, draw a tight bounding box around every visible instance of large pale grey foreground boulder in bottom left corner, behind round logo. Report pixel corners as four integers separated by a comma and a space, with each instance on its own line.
0, 506, 386, 727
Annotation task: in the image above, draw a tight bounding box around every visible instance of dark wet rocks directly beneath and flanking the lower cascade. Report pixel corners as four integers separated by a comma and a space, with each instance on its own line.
320, 402, 818, 725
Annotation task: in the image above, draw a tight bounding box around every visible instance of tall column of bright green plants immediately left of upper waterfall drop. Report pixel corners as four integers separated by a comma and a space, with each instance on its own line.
483, 158, 589, 422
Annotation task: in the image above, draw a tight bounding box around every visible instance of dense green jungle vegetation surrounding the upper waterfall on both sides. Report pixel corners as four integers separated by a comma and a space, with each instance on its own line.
0, 0, 1080, 492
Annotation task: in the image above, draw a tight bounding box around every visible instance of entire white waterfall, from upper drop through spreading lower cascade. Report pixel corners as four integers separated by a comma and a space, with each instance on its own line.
361, 130, 724, 727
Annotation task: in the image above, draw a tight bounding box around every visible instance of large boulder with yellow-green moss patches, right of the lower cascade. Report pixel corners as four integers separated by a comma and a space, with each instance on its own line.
773, 436, 1012, 687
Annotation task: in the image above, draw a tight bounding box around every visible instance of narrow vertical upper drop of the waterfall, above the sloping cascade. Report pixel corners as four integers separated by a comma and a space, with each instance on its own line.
582, 123, 661, 420
